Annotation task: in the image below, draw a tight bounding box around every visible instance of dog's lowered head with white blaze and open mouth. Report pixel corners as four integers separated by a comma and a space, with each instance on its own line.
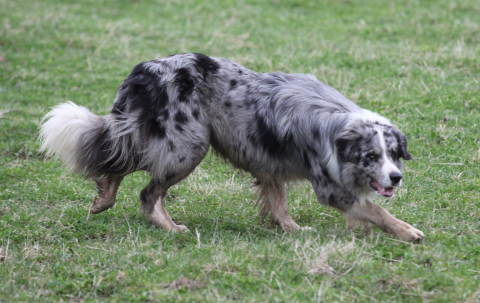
335, 121, 412, 197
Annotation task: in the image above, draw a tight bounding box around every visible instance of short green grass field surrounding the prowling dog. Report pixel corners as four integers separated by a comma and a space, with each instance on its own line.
0, 0, 480, 302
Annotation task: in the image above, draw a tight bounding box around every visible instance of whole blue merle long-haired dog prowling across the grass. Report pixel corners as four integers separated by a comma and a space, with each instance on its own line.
40, 53, 424, 241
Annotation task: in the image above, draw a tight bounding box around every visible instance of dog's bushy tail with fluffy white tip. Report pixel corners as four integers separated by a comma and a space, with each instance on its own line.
40, 101, 127, 178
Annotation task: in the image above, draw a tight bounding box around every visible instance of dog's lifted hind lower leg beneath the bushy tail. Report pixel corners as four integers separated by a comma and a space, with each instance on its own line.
90, 175, 123, 214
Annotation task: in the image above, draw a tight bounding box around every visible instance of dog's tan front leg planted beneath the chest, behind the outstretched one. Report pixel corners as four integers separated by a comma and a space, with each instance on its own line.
256, 182, 300, 232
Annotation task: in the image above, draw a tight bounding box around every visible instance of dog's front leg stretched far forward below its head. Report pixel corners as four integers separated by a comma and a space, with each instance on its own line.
344, 200, 425, 241
